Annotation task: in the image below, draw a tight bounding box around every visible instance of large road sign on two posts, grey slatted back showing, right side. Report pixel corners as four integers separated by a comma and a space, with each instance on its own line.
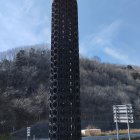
113, 104, 134, 140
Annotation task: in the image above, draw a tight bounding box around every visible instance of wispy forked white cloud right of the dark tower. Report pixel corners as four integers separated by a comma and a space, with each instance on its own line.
80, 20, 129, 63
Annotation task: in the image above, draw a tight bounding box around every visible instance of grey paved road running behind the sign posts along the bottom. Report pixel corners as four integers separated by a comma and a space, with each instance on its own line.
40, 134, 140, 140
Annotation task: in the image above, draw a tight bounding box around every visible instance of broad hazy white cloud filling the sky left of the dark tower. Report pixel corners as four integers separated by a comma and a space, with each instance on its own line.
0, 0, 51, 51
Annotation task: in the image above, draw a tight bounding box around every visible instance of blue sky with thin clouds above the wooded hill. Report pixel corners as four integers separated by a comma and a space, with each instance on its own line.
0, 0, 140, 66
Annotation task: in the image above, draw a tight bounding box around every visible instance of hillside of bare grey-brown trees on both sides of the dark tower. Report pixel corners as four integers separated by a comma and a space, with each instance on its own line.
0, 48, 140, 131
